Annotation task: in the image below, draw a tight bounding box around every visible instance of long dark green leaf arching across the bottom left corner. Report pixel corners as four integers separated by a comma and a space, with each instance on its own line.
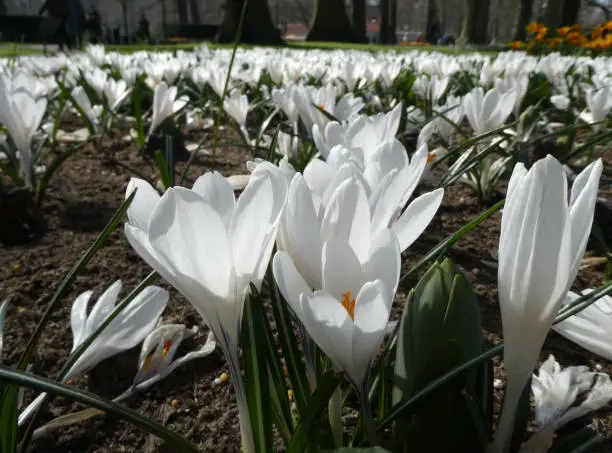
0, 365, 198, 453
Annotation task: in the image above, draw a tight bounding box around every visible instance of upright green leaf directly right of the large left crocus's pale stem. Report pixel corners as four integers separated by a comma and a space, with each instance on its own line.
242, 296, 273, 453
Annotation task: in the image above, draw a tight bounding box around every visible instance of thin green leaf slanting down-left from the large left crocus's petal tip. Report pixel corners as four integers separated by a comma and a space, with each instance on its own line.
17, 190, 136, 371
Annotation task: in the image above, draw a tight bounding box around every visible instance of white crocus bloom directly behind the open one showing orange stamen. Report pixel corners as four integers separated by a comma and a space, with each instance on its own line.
278, 173, 443, 289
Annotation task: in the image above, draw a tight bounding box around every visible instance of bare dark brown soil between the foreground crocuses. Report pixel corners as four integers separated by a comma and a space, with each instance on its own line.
0, 118, 612, 453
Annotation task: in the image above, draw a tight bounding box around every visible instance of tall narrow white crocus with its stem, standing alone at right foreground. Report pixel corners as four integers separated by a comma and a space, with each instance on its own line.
495, 156, 602, 451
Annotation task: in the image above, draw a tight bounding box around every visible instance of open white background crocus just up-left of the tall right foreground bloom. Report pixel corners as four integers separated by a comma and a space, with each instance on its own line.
463, 87, 517, 135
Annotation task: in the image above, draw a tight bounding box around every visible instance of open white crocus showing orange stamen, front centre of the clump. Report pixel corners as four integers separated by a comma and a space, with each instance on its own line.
272, 226, 401, 389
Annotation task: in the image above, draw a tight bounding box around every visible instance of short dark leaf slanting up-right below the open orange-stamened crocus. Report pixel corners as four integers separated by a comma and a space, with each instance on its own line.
287, 371, 339, 453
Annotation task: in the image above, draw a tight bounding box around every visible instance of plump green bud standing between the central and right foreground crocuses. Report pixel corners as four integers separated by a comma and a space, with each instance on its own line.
393, 260, 486, 452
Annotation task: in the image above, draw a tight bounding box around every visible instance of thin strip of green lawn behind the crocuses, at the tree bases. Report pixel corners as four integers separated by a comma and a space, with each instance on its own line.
0, 41, 498, 58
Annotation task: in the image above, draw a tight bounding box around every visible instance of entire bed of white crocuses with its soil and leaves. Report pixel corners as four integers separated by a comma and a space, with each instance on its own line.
0, 46, 612, 453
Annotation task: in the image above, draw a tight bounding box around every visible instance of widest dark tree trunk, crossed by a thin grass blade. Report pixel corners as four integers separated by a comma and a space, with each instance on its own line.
217, 0, 286, 46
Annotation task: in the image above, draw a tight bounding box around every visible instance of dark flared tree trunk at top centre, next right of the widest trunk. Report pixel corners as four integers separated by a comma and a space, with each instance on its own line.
306, 0, 355, 42
